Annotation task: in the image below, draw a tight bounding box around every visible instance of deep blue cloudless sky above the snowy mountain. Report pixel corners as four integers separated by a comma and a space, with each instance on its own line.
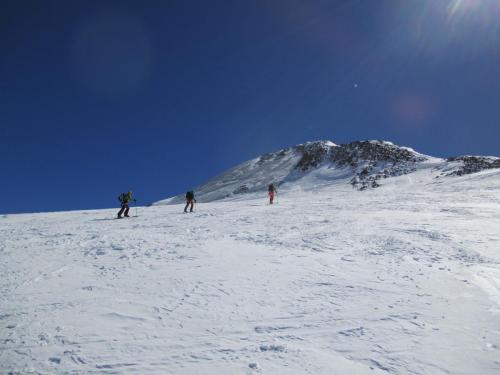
0, 0, 500, 213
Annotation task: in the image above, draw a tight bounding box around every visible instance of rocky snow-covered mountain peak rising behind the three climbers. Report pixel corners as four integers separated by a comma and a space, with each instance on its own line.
154, 141, 500, 205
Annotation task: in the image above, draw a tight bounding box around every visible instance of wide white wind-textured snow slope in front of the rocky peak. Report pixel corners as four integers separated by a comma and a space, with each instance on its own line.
0, 170, 500, 375
